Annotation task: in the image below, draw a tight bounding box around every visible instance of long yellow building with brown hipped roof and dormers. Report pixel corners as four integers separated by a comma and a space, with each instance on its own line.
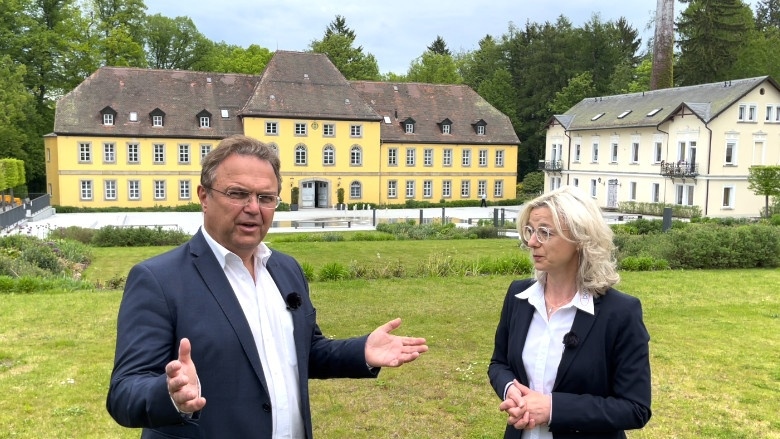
44, 51, 520, 208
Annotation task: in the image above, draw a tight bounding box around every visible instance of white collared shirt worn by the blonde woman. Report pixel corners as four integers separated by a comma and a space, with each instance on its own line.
515, 282, 594, 439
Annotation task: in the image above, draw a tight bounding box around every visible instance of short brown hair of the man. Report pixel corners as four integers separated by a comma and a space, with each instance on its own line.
200, 135, 282, 195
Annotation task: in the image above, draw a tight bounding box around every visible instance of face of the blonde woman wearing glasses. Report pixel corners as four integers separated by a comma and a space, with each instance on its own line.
528, 207, 579, 277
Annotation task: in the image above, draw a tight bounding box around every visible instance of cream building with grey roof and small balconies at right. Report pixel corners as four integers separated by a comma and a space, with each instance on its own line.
540, 76, 780, 217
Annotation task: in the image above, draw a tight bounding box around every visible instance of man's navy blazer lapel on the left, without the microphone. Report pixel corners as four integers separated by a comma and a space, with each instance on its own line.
190, 230, 268, 393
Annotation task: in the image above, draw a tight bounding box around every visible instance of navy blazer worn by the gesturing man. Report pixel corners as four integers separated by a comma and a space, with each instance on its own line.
106, 231, 376, 439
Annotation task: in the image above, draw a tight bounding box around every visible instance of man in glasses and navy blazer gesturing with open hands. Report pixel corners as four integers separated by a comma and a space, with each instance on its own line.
106, 136, 428, 439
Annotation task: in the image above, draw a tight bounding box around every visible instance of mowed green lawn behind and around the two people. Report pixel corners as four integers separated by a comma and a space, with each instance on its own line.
0, 240, 780, 439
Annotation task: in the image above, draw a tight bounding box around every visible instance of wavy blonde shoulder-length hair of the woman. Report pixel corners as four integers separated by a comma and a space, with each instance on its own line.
517, 186, 620, 295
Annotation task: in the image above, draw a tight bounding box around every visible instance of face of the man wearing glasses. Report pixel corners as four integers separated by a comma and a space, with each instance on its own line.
198, 154, 279, 260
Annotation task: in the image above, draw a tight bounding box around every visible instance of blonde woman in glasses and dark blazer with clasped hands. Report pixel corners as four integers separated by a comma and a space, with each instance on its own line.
488, 186, 650, 439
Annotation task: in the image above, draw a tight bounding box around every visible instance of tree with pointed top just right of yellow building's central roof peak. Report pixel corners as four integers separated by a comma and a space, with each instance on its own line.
309, 15, 379, 81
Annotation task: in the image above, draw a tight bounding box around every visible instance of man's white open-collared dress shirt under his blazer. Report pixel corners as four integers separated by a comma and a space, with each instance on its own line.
203, 228, 305, 439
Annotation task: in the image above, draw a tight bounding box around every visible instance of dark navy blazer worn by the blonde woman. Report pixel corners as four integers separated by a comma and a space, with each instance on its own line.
488, 279, 651, 439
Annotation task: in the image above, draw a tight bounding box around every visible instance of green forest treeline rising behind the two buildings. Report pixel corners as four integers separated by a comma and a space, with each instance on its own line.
0, 0, 780, 196
